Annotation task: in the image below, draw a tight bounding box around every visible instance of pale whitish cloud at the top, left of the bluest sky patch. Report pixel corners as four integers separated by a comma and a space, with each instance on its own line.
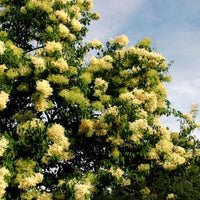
87, 0, 145, 42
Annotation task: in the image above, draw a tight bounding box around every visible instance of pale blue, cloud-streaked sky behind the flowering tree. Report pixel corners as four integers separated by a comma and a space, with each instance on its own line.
86, 0, 200, 138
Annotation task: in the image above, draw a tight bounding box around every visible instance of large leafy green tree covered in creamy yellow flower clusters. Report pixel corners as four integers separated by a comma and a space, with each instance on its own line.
0, 0, 199, 200
